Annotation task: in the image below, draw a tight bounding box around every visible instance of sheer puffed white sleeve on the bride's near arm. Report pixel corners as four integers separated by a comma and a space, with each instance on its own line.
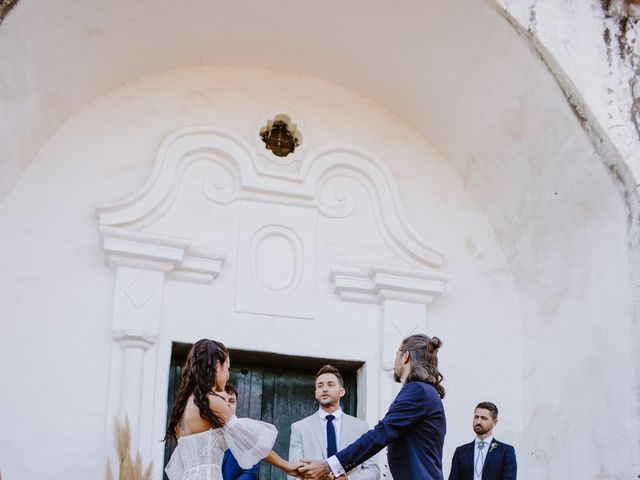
222, 416, 278, 468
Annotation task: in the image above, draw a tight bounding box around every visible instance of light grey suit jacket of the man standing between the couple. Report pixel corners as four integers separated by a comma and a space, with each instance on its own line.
287, 412, 380, 480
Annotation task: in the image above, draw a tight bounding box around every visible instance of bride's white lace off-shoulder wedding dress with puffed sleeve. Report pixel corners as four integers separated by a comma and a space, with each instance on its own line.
165, 416, 278, 480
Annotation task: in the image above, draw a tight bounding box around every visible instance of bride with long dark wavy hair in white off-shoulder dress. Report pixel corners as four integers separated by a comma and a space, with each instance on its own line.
165, 339, 301, 480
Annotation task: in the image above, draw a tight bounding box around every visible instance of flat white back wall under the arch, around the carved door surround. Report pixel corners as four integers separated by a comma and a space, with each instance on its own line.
0, 69, 522, 479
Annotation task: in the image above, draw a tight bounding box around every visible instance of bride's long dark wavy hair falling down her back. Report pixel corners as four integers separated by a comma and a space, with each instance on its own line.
164, 338, 229, 441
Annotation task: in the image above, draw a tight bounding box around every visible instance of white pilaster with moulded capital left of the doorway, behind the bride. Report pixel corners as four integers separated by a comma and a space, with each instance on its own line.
100, 226, 226, 458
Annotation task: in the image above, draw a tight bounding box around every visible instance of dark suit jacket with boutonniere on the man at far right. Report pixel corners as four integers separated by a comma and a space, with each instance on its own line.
449, 438, 518, 480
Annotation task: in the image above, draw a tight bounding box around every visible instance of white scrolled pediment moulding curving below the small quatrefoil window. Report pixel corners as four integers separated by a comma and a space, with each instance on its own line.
97, 127, 442, 268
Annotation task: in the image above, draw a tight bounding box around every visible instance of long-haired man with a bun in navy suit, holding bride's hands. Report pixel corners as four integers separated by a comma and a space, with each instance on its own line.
298, 335, 446, 480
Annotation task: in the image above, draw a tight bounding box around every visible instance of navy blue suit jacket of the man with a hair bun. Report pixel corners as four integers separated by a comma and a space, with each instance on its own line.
336, 382, 447, 480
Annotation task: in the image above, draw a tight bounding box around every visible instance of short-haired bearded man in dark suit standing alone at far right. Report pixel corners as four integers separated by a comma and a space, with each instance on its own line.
449, 402, 518, 480
